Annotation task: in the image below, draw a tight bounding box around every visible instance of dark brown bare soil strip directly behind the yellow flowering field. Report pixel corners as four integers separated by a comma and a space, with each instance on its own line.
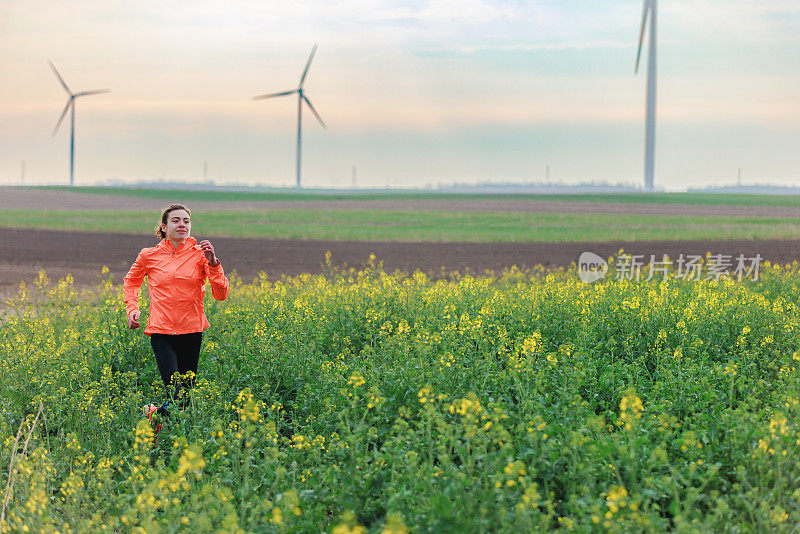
0, 228, 800, 296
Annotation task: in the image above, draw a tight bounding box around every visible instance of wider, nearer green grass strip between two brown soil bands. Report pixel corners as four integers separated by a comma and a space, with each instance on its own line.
0, 209, 800, 242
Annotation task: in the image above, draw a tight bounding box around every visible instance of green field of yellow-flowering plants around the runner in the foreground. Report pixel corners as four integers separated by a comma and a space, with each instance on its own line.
0, 263, 800, 533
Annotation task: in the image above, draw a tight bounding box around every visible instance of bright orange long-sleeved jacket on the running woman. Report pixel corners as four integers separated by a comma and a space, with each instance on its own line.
123, 237, 228, 335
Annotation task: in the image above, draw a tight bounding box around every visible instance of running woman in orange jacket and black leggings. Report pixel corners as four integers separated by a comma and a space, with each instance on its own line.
123, 204, 228, 419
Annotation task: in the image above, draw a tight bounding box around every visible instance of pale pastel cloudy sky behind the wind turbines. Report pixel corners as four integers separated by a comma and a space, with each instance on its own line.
0, 0, 800, 190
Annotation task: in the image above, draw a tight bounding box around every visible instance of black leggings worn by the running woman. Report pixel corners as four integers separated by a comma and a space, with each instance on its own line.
150, 332, 203, 399
